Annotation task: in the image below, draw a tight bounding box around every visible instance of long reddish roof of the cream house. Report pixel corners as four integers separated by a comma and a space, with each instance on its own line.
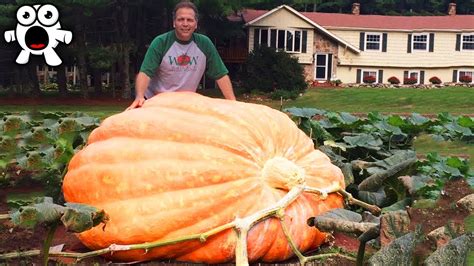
242, 9, 474, 30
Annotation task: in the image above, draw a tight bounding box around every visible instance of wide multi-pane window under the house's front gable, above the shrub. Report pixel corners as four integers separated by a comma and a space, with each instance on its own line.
258, 29, 303, 53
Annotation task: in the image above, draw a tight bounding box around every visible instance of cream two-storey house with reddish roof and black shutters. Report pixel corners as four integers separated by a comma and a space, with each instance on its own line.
242, 3, 474, 84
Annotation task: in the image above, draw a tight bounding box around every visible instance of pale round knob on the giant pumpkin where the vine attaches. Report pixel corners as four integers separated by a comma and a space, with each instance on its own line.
262, 157, 306, 190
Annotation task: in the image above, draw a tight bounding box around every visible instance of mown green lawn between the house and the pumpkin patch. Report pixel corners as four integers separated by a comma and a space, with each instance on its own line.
284, 87, 474, 114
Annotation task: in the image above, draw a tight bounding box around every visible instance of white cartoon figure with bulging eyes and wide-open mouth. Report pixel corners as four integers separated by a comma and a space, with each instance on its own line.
4, 4, 72, 66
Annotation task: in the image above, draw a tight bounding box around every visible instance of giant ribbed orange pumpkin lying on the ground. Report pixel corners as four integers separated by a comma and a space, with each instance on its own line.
63, 92, 344, 263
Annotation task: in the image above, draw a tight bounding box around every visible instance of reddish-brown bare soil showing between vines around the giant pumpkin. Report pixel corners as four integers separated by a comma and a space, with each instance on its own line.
0, 180, 474, 266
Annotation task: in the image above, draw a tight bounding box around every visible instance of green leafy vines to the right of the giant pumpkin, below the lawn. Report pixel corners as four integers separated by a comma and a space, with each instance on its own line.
286, 108, 474, 209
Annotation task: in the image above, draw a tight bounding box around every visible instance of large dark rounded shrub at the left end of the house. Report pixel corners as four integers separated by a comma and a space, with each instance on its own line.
242, 46, 308, 92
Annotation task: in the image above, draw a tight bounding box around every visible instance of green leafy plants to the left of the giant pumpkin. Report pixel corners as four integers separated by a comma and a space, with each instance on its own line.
0, 112, 99, 200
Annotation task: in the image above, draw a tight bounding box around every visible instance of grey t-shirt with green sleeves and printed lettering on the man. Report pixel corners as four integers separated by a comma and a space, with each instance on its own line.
140, 30, 229, 98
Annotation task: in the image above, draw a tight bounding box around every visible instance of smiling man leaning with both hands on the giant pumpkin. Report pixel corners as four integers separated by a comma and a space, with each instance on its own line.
127, 1, 235, 110
